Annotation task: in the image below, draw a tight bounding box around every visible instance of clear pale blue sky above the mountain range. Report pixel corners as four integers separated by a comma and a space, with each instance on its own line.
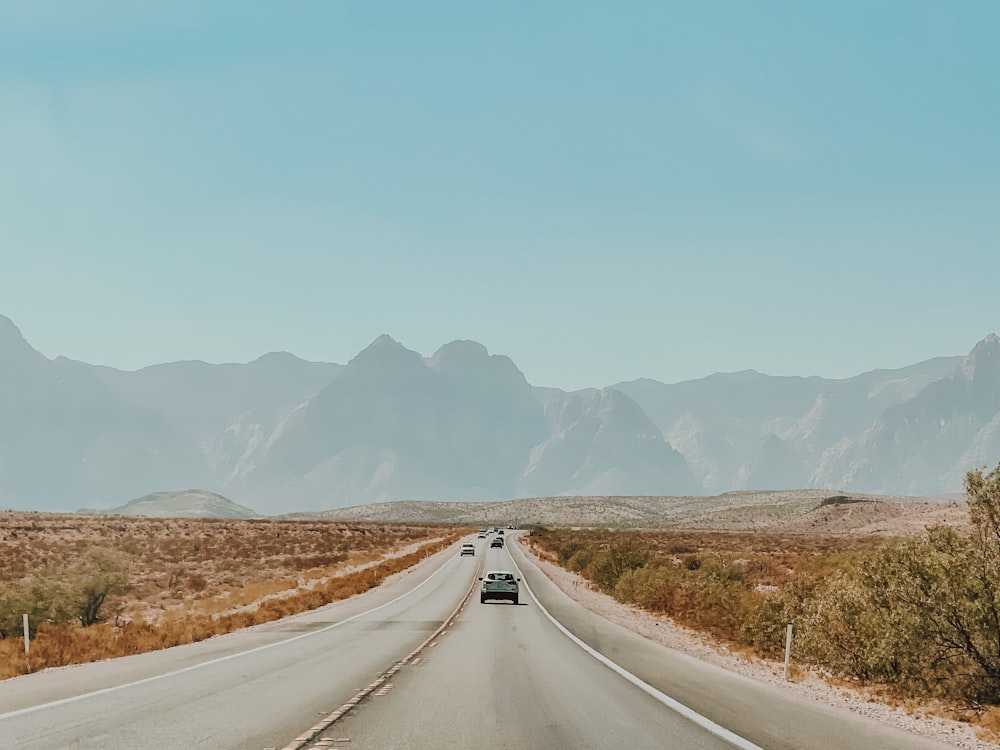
0, 5, 1000, 389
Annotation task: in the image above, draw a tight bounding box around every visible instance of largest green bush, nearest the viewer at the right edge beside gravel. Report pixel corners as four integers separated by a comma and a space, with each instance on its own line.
788, 467, 1000, 706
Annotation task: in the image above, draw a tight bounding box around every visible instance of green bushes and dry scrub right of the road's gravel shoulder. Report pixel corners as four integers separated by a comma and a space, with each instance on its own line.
532, 467, 1000, 715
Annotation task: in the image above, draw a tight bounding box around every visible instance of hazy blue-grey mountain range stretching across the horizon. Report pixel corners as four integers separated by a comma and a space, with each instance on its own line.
0, 316, 1000, 515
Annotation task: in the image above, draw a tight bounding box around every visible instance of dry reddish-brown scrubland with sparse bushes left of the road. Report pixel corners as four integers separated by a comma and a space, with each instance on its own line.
0, 512, 463, 679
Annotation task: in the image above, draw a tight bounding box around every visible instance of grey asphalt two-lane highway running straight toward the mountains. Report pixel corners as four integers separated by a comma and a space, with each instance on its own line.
0, 540, 947, 750
